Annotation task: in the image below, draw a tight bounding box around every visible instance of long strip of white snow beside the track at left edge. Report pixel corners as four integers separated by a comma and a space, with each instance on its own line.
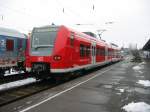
0, 78, 36, 91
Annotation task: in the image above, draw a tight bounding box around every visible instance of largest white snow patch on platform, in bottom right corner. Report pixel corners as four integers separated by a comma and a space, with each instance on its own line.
122, 102, 150, 112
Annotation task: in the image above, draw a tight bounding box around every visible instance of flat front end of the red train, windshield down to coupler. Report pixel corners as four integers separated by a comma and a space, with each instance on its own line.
26, 26, 59, 75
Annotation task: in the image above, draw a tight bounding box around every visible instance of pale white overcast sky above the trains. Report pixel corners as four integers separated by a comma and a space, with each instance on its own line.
0, 0, 150, 48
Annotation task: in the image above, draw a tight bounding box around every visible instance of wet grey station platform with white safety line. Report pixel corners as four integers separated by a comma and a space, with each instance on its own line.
0, 59, 150, 112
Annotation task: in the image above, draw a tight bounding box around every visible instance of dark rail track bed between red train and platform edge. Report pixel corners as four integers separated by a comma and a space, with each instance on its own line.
0, 61, 118, 107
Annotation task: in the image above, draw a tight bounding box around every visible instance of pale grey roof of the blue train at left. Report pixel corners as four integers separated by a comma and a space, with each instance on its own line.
0, 27, 26, 38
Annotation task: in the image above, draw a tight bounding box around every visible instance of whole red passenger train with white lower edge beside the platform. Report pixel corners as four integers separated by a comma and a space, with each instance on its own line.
26, 25, 121, 78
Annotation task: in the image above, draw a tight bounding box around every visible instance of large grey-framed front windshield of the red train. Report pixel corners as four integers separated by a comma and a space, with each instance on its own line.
31, 27, 58, 55
